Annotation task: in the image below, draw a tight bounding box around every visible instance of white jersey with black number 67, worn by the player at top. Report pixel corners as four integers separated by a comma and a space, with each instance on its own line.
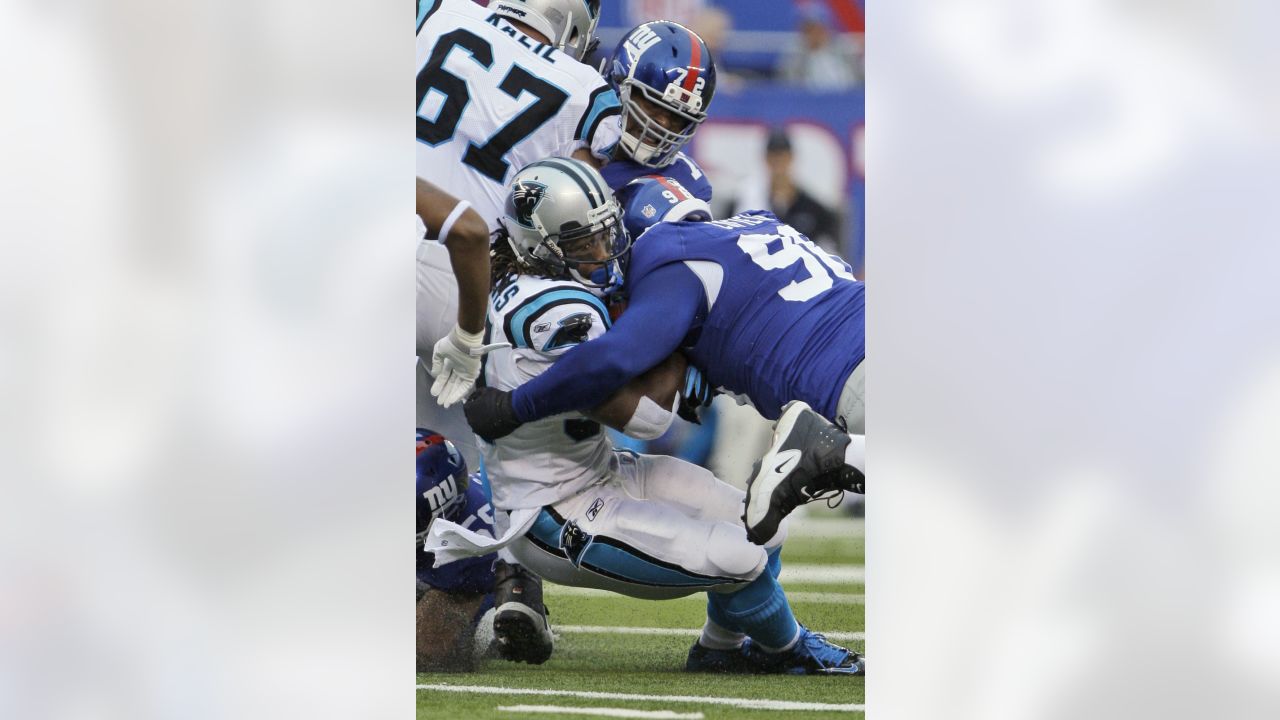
417, 0, 622, 231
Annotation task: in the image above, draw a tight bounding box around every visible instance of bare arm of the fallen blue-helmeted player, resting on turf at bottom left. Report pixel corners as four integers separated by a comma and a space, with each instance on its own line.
417, 588, 484, 673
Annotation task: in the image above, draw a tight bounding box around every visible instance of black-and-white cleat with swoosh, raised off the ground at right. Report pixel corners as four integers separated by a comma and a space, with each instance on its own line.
742, 400, 864, 544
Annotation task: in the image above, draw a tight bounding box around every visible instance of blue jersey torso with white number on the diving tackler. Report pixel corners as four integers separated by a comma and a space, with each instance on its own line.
627, 211, 865, 419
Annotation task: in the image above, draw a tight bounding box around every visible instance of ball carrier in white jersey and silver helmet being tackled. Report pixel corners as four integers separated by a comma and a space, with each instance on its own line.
428, 159, 865, 675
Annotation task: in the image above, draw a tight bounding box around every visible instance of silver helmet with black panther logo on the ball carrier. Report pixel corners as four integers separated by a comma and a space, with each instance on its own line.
502, 158, 631, 295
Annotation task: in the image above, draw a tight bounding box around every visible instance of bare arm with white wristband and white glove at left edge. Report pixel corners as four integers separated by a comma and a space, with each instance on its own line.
417, 178, 504, 407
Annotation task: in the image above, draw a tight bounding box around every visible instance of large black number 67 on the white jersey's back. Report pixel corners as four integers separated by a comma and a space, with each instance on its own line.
417, 28, 568, 182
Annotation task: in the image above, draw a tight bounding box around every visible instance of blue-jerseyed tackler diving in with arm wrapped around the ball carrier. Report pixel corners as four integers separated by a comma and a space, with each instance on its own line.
466, 178, 865, 543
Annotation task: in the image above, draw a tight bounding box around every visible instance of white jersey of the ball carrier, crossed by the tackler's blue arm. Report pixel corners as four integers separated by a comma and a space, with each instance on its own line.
480, 275, 617, 510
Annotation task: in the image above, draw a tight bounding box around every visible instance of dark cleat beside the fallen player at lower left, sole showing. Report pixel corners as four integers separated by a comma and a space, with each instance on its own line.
493, 560, 556, 665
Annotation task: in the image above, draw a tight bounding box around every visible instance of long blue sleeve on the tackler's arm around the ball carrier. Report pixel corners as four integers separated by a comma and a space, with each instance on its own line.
511, 263, 705, 423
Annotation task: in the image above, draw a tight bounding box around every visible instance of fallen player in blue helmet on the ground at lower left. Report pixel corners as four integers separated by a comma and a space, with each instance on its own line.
417, 428, 553, 673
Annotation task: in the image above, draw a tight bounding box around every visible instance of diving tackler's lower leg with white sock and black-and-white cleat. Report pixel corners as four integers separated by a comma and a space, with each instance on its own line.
742, 364, 867, 543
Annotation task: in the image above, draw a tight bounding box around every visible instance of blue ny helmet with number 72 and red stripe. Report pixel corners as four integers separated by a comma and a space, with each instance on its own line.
609, 20, 716, 168
